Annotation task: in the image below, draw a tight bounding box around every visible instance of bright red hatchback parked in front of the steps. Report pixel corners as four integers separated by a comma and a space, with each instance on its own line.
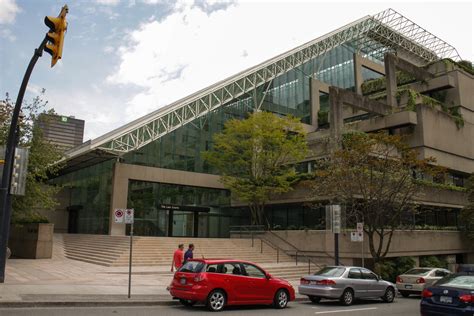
169, 259, 295, 312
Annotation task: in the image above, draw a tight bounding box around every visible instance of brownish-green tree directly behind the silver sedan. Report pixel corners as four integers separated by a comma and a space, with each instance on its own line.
311, 132, 438, 263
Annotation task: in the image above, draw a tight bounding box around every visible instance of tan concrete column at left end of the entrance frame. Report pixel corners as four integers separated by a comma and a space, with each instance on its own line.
109, 162, 128, 236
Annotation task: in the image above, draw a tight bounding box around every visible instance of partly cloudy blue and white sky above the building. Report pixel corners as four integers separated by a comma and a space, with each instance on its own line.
0, 0, 474, 141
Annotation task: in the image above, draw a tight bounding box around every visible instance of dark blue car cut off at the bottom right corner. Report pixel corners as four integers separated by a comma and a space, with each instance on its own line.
420, 272, 474, 316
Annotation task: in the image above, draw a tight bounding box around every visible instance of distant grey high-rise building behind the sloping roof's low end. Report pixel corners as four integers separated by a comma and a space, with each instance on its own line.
38, 114, 84, 150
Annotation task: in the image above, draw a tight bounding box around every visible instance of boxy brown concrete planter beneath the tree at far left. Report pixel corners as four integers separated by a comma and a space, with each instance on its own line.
8, 223, 54, 259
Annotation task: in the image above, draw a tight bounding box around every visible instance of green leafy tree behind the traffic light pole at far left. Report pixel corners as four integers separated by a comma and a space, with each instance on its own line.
0, 90, 62, 222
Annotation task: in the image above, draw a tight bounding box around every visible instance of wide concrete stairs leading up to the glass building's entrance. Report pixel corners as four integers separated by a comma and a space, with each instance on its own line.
58, 234, 316, 280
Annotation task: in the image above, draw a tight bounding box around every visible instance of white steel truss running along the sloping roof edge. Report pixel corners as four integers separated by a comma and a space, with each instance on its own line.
67, 9, 459, 157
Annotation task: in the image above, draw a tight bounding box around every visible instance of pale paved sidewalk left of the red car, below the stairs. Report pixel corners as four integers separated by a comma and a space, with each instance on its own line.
0, 237, 304, 307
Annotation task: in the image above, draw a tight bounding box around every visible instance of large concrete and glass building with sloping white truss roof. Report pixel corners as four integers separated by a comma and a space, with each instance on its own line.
52, 9, 474, 261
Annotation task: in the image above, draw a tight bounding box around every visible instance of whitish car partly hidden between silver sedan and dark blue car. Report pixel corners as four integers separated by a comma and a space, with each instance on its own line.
396, 268, 451, 297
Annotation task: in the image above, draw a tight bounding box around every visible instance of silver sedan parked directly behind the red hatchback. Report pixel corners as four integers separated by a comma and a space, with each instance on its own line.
298, 266, 396, 305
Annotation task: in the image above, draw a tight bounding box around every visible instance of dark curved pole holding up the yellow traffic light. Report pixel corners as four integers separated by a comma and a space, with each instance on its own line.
0, 37, 48, 283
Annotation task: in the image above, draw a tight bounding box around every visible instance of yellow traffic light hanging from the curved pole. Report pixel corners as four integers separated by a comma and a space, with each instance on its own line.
44, 5, 69, 67
